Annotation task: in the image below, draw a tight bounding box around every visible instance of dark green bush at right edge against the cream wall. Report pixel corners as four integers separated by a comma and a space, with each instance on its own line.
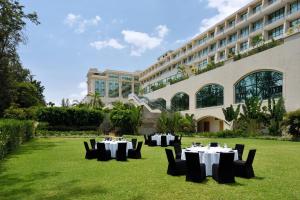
284, 109, 300, 138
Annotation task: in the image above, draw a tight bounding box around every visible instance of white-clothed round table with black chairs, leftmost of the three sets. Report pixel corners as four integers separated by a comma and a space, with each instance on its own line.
84, 137, 143, 161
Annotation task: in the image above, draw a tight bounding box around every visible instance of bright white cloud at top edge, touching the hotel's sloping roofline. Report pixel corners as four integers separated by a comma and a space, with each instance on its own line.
199, 0, 251, 33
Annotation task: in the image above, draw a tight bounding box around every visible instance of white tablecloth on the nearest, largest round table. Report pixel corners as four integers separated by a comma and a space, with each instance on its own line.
181, 147, 238, 176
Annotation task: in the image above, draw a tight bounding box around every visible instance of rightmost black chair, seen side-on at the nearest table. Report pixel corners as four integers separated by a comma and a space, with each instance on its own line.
233, 149, 256, 178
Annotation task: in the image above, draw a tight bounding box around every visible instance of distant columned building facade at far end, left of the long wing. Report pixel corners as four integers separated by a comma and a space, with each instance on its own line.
87, 68, 140, 104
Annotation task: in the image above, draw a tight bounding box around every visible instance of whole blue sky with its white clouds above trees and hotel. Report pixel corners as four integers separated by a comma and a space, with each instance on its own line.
19, 0, 249, 104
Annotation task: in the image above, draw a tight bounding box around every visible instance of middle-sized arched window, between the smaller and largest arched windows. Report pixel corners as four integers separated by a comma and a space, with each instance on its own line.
196, 84, 224, 108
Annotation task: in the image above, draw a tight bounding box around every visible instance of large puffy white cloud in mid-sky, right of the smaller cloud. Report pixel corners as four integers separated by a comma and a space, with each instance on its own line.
122, 25, 169, 56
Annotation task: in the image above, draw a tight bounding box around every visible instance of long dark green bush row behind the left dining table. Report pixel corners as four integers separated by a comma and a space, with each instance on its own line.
37, 107, 104, 131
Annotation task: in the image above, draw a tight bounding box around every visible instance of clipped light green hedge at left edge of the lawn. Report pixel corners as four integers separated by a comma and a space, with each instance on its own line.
0, 119, 35, 160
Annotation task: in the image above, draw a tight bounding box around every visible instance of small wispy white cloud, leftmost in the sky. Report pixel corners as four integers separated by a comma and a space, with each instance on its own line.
64, 13, 101, 33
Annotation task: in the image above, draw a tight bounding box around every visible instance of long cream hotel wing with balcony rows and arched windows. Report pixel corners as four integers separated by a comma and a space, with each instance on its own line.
89, 0, 300, 132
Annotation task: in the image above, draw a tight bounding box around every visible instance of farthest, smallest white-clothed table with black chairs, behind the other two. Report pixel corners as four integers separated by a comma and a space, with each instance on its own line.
144, 133, 182, 147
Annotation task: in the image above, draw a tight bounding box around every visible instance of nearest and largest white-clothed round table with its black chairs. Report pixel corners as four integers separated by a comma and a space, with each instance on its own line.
165, 143, 256, 183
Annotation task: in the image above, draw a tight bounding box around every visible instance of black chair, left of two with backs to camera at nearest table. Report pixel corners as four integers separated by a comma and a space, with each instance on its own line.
185, 152, 206, 183
